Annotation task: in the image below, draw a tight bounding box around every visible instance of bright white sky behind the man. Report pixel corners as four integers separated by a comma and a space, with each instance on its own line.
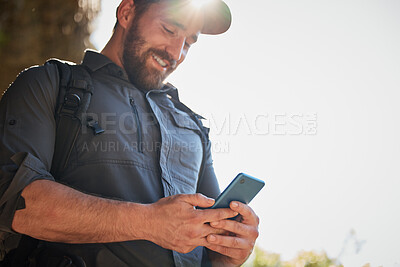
92, 0, 400, 267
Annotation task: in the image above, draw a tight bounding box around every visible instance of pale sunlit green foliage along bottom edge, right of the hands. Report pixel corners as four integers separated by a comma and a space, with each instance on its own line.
246, 247, 343, 267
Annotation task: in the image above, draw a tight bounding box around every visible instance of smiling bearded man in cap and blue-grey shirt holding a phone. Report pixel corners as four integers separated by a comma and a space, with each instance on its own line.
0, 0, 258, 266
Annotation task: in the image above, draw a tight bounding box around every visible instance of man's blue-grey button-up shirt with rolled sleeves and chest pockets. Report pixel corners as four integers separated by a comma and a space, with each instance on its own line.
0, 51, 219, 266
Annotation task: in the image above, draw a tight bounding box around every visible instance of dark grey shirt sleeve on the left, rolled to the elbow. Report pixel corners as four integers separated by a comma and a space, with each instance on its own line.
0, 64, 59, 233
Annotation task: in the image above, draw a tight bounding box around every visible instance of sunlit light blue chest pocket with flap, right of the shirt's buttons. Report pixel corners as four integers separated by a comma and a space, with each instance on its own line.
168, 109, 203, 193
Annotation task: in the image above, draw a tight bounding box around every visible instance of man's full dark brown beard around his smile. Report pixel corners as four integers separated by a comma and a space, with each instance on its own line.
122, 18, 176, 91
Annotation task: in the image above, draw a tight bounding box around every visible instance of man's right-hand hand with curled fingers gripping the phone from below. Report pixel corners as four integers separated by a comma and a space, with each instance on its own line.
206, 201, 259, 266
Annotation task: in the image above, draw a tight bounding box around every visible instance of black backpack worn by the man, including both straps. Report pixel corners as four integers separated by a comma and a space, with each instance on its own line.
0, 59, 210, 267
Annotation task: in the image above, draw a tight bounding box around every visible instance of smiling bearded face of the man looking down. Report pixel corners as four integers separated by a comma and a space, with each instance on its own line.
122, 1, 203, 91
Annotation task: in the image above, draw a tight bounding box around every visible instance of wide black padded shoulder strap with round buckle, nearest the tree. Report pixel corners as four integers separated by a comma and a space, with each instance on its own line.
47, 59, 93, 178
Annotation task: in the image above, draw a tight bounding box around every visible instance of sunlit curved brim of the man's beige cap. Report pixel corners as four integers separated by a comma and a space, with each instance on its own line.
201, 0, 232, 35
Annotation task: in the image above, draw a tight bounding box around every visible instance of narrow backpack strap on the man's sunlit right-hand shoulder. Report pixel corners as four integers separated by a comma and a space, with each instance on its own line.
167, 89, 210, 187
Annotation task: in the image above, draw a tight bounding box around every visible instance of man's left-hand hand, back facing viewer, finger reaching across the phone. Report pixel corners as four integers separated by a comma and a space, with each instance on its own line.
143, 194, 238, 253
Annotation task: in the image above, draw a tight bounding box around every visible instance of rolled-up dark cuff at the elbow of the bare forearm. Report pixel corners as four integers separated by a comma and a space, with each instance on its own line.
0, 152, 54, 233
